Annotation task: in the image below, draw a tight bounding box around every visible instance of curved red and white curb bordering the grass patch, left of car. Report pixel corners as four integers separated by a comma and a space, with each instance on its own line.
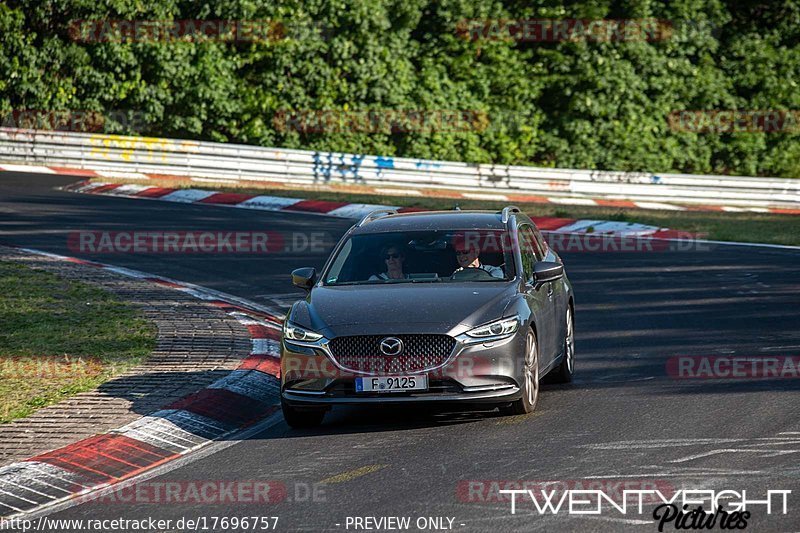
0, 248, 283, 518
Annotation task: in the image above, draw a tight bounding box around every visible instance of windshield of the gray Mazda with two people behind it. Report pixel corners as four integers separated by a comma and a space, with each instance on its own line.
324, 230, 514, 285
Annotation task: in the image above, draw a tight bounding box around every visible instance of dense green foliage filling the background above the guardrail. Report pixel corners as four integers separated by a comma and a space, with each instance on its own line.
0, 0, 800, 177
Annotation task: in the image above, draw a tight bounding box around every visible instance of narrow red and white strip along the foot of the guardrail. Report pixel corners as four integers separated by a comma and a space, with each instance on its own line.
0, 164, 800, 216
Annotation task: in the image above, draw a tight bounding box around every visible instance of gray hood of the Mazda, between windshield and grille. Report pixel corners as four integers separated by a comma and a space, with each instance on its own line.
290, 282, 516, 336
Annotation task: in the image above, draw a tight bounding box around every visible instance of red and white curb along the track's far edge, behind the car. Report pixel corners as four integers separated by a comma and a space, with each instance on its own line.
65, 181, 687, 239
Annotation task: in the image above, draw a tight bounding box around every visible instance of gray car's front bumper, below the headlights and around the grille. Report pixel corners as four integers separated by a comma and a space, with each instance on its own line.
281, 332, 525, 406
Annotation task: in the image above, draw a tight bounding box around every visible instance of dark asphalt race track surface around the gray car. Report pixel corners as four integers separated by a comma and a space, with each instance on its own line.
0, 173, 800, 532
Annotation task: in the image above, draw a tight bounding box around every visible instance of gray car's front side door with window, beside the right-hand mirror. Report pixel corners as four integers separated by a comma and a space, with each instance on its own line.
518, 223, 557, 369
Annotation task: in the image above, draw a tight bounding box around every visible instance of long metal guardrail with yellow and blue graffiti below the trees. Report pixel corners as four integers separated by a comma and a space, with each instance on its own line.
0, 128, 800, 208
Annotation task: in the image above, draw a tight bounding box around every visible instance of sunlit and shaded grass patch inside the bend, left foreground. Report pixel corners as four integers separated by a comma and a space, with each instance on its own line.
0, 262, 156, 423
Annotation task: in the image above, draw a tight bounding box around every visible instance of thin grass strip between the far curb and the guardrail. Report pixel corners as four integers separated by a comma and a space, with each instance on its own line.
87, 178, 800, 246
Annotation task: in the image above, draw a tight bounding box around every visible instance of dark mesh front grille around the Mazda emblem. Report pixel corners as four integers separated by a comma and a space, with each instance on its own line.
328, 335, 456, 375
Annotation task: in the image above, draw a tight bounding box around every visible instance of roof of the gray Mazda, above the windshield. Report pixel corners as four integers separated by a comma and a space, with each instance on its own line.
353, 211, 520, 233
